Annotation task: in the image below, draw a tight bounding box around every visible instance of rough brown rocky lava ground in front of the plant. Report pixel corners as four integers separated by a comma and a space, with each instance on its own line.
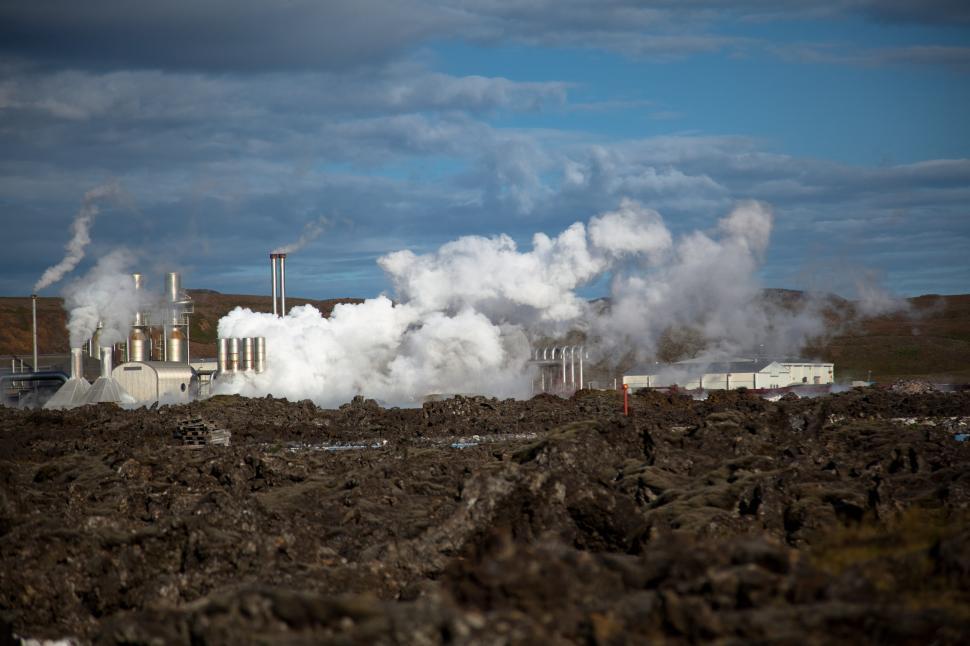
0, 389, 970, 644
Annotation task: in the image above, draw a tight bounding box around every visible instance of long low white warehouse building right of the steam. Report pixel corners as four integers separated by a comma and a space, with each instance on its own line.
623, 359, 835, 390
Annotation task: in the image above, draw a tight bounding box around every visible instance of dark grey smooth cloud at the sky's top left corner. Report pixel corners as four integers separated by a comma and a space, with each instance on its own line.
0, 0, 456, 71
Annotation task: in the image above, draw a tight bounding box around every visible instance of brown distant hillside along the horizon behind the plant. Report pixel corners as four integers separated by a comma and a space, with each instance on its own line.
0, 290, 970, 383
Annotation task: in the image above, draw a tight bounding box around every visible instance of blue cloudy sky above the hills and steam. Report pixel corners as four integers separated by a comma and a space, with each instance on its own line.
0, 0, 970, 298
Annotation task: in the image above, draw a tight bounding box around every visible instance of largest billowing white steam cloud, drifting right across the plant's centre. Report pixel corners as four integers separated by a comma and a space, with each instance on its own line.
217, 200, 896, 406
